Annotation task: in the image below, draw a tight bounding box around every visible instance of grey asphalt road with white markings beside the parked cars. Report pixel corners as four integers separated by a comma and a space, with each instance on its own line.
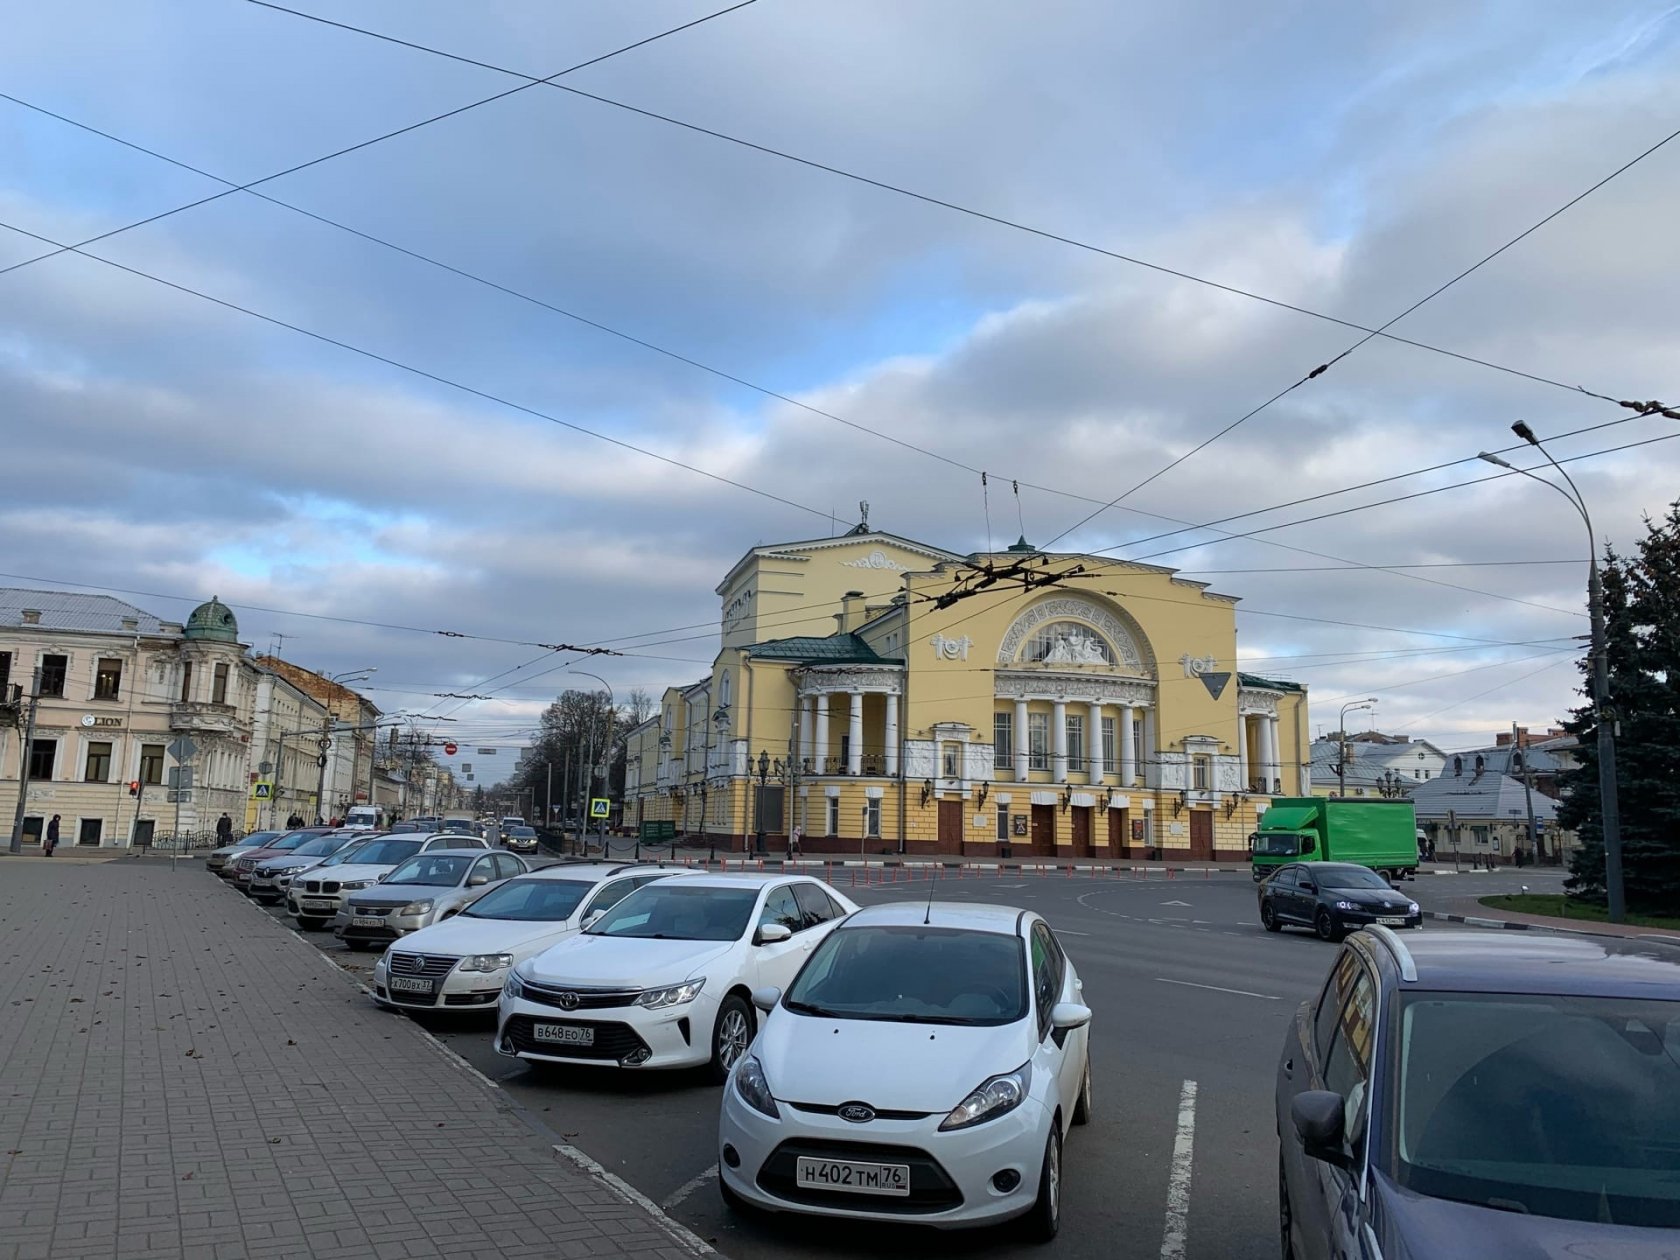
243, 870, 1538, 1260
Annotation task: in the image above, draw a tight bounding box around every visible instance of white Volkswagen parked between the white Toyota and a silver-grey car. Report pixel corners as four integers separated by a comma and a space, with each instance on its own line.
373, 862, 692, 1011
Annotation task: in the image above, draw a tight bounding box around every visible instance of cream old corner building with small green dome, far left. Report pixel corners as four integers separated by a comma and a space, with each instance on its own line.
0, 588, 347, 847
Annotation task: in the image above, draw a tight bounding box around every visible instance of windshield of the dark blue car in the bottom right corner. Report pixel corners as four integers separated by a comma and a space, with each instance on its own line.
1394, 993, 1680, 1230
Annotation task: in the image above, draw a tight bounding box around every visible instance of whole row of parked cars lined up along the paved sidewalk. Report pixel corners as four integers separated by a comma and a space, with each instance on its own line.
212, 833, 1092, 1238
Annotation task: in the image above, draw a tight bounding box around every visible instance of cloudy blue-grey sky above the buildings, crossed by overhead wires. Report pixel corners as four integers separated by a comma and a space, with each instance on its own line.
0, 0, 1680, 769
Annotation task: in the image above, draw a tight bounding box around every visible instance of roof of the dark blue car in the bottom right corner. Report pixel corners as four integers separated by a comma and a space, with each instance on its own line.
1366, 931, 1680, 1001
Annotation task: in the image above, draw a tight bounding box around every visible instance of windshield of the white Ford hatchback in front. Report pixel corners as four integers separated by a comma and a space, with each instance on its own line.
783, 926, 1026, 1026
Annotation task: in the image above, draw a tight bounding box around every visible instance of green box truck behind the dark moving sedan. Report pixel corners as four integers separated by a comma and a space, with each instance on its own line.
1248, 796, 1418, 884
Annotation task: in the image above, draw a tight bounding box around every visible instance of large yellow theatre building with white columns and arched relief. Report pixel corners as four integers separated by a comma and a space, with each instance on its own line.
623, 526, 1310, 860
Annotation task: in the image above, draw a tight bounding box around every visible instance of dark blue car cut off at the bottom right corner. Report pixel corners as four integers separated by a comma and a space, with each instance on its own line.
1277, 927, 1680, 1260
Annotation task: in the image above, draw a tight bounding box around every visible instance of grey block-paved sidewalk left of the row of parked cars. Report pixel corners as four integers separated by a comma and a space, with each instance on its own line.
0, 860, 704, 1260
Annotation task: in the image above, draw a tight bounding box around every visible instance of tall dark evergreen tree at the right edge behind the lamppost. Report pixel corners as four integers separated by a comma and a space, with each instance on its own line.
1557, 501, 1680, 914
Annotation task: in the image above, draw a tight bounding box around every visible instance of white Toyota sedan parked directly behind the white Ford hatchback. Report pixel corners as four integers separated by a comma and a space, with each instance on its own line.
496, 874, 857, 1080
